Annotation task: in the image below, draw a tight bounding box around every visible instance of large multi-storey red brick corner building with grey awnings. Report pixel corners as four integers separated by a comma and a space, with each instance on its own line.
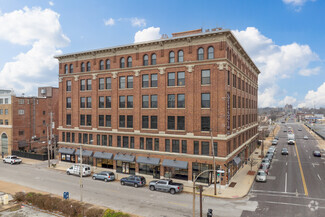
56, 29, 260, 185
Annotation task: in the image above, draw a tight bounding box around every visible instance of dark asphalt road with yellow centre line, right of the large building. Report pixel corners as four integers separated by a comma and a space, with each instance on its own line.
242, 121, 325, 217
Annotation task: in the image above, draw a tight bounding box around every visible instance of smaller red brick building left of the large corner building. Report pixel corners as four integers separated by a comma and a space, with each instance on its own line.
12, 87, 59, 152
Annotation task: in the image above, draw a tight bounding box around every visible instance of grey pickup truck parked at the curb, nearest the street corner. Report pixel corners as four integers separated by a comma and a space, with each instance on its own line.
149, 179, 184, 194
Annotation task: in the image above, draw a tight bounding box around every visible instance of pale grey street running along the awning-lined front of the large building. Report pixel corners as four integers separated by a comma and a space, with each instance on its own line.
0, 162, 257, 217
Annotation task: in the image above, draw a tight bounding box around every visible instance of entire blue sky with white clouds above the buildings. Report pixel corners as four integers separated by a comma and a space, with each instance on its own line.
0, 0, 325, 108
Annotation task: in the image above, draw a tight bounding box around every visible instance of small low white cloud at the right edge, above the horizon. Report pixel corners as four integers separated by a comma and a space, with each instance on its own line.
298, 82, 325, 108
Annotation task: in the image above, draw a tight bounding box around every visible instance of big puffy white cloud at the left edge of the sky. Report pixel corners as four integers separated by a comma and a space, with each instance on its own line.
0, 7, 70, 95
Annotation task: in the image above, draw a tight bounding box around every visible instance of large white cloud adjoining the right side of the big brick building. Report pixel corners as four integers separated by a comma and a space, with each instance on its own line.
233, 27, 319, 107
